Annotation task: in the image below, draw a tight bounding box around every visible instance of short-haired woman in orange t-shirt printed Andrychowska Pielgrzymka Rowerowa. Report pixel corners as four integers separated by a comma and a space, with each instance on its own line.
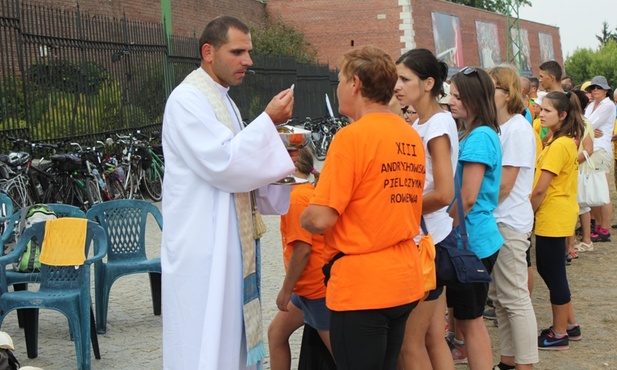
300, 46, 426, 370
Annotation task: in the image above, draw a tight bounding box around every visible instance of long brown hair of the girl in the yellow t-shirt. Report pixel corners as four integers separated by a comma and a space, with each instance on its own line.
542, 91, 585, 141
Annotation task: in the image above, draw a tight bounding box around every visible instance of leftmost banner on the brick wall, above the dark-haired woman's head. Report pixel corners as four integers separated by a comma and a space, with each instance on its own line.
431, 12, 465, 67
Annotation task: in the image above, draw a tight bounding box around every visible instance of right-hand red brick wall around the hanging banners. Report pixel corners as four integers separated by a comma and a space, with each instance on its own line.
266, 0, 563, 75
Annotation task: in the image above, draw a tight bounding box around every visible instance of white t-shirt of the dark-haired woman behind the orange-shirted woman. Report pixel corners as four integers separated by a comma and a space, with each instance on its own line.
412, 111, 458, 244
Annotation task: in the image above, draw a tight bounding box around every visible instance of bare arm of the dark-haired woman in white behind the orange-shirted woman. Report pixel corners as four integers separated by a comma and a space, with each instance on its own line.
422, 134, 454, 215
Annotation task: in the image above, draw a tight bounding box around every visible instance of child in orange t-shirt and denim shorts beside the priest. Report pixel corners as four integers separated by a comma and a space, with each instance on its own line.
268, 147, 330, 370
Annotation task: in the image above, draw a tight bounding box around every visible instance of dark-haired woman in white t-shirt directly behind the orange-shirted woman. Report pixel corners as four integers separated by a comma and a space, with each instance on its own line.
394, 49, 458, 369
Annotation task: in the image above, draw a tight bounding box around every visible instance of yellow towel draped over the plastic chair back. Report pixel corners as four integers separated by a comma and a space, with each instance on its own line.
39, 217, 88, 266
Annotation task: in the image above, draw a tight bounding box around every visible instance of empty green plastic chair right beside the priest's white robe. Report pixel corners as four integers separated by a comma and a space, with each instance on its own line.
86, 199, 163, 334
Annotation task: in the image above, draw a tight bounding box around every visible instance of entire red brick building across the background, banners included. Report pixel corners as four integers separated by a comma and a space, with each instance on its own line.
27, 0, 563, 75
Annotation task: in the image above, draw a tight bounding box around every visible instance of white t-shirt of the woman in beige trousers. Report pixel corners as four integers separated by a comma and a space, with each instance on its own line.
493, 114, 536, 233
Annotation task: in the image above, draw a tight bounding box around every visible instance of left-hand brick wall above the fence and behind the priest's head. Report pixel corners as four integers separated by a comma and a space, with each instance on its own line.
30, 0, 265, 37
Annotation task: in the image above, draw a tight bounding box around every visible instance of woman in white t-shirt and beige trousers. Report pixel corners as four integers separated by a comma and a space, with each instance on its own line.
488, 66, 541, 370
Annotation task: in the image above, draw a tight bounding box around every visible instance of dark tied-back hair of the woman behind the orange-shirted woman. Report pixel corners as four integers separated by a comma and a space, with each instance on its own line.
396, 49, 448, 99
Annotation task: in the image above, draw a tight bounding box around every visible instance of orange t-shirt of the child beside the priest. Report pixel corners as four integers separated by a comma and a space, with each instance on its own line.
281, 183, 326, 299
